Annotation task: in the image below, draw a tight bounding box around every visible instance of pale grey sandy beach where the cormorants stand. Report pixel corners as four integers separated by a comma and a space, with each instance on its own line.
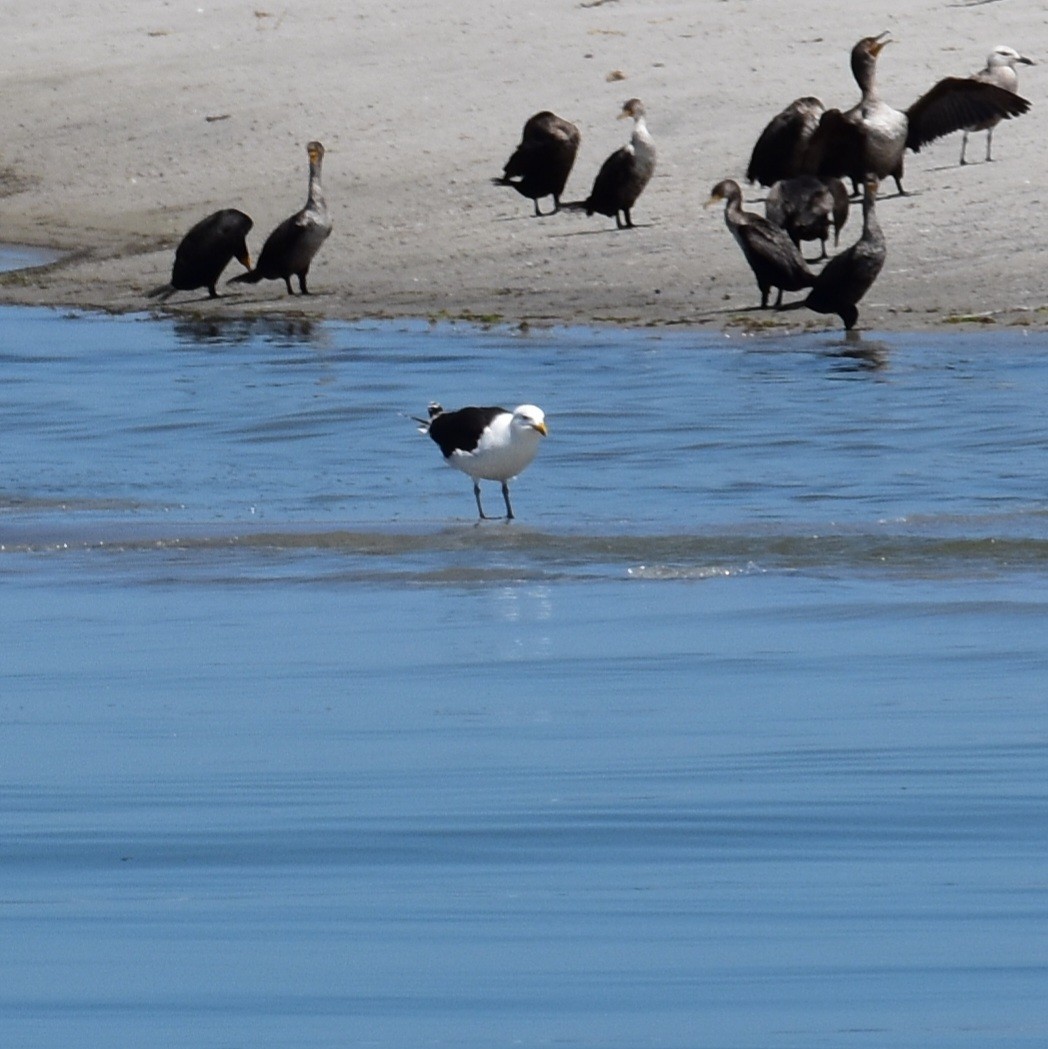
0, 0, 1048, 330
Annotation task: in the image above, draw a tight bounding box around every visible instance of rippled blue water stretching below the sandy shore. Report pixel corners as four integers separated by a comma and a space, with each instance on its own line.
0, 309, 1048, 1049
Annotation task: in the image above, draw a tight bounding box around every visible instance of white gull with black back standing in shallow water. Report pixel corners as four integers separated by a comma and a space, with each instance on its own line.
415, 403, 549, 520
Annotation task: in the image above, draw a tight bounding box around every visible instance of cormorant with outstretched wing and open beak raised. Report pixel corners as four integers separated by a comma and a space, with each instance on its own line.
806, 33, 1030, 193
